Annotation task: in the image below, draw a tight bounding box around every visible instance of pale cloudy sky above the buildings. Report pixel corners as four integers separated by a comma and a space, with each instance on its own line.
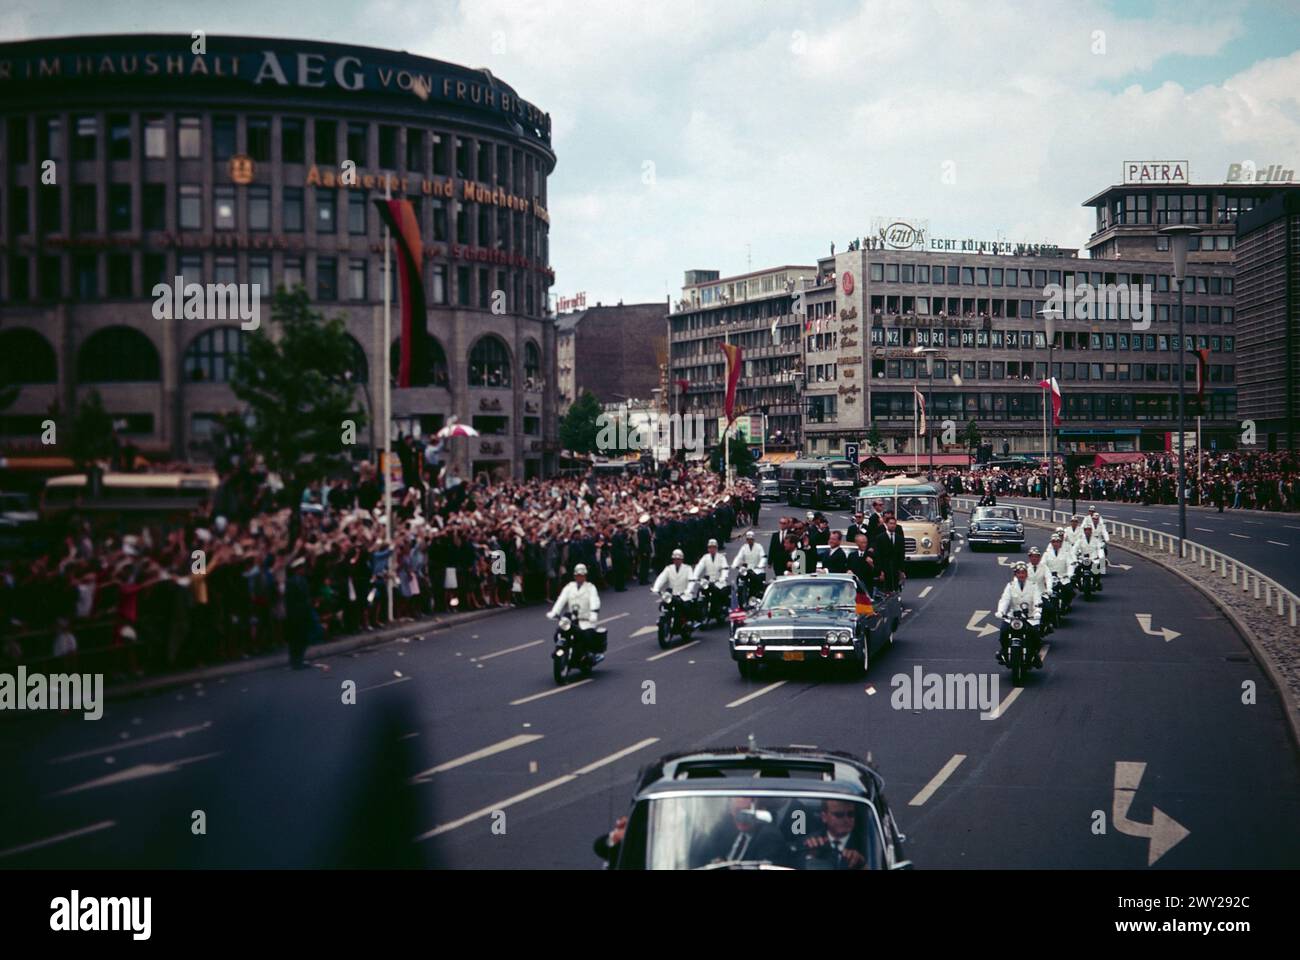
0, 0, 1300, 303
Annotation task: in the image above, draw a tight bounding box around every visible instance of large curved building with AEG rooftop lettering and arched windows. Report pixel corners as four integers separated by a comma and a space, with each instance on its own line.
0, 35, 556, 477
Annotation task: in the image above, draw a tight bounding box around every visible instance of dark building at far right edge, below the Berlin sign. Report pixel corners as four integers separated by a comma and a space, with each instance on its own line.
1236, 191, 1300, 450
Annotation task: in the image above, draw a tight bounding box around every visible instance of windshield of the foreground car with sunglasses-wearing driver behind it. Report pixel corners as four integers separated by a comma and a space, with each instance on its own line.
646, 793, 883, 870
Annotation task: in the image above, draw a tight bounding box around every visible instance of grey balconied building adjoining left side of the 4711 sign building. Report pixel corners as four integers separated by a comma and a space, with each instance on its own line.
668, 265, 816, 450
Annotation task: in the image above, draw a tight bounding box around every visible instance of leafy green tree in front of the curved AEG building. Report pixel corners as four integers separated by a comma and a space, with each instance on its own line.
224, 286, 367, 509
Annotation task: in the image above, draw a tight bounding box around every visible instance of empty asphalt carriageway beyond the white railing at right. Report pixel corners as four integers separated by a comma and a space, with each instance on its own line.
982, 494, 1300, 593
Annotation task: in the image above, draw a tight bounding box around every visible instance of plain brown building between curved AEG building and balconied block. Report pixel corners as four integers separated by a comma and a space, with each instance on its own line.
555, 302, 668, 416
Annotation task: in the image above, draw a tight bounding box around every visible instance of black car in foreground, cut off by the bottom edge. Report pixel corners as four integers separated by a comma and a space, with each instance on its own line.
595, 747, 911, 870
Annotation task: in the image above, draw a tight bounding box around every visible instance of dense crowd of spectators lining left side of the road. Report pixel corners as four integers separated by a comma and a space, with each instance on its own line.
0, 442, 759, 675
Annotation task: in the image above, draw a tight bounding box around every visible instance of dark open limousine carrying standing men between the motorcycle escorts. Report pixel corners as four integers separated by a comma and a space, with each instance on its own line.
731, 574, 902, 679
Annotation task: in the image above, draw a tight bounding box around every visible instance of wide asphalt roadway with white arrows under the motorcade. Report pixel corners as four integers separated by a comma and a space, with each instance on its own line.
0, 510, 1300, 869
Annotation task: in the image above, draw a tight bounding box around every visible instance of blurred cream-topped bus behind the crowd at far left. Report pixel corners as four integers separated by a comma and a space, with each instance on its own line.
40, 471, 221, 519
